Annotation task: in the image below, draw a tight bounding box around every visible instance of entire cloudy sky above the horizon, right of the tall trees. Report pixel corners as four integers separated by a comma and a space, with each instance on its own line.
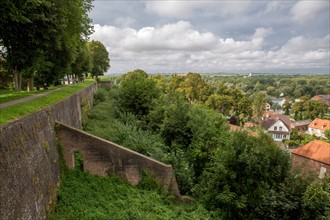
89, 0, 330, 74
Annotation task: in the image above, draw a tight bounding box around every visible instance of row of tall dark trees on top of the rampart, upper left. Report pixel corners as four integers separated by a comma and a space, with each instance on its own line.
0, 0, 110, 91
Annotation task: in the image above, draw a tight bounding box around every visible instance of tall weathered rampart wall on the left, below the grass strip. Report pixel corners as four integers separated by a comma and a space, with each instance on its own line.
0, 83, 97, 220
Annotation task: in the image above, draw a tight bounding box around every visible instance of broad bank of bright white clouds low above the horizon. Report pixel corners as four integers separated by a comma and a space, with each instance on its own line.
91, 21, 330, 73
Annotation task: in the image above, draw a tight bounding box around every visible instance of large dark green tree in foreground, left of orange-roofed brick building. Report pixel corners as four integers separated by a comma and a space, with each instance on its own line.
194, 132, 290, 219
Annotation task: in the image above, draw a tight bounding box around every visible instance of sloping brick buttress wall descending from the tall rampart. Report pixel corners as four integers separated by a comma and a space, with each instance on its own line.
56, 123, 180, 197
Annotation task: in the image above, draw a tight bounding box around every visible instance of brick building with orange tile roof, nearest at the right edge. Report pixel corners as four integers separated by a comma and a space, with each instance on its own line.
291, 140, 330, 179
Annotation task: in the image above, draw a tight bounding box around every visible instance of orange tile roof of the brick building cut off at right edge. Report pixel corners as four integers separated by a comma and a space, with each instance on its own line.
292, 140, 330, 165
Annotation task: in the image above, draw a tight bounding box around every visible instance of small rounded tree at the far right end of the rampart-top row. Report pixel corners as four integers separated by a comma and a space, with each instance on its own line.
87, 40, 110, 79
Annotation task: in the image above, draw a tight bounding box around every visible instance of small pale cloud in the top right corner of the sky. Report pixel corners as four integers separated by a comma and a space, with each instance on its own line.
291, 0, 330, 23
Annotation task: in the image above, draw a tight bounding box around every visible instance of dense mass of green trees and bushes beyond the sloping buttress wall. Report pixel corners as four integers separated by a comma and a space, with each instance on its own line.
86, 70, 330, 219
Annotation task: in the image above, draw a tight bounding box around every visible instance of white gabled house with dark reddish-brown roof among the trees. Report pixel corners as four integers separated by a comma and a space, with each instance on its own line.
261, 115, 291, 141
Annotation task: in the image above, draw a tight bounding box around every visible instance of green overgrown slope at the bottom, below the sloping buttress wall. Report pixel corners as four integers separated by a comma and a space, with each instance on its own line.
50, 170, 211, 220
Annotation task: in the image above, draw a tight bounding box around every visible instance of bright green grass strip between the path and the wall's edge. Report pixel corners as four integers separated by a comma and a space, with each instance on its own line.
0, 80, 95, 125
